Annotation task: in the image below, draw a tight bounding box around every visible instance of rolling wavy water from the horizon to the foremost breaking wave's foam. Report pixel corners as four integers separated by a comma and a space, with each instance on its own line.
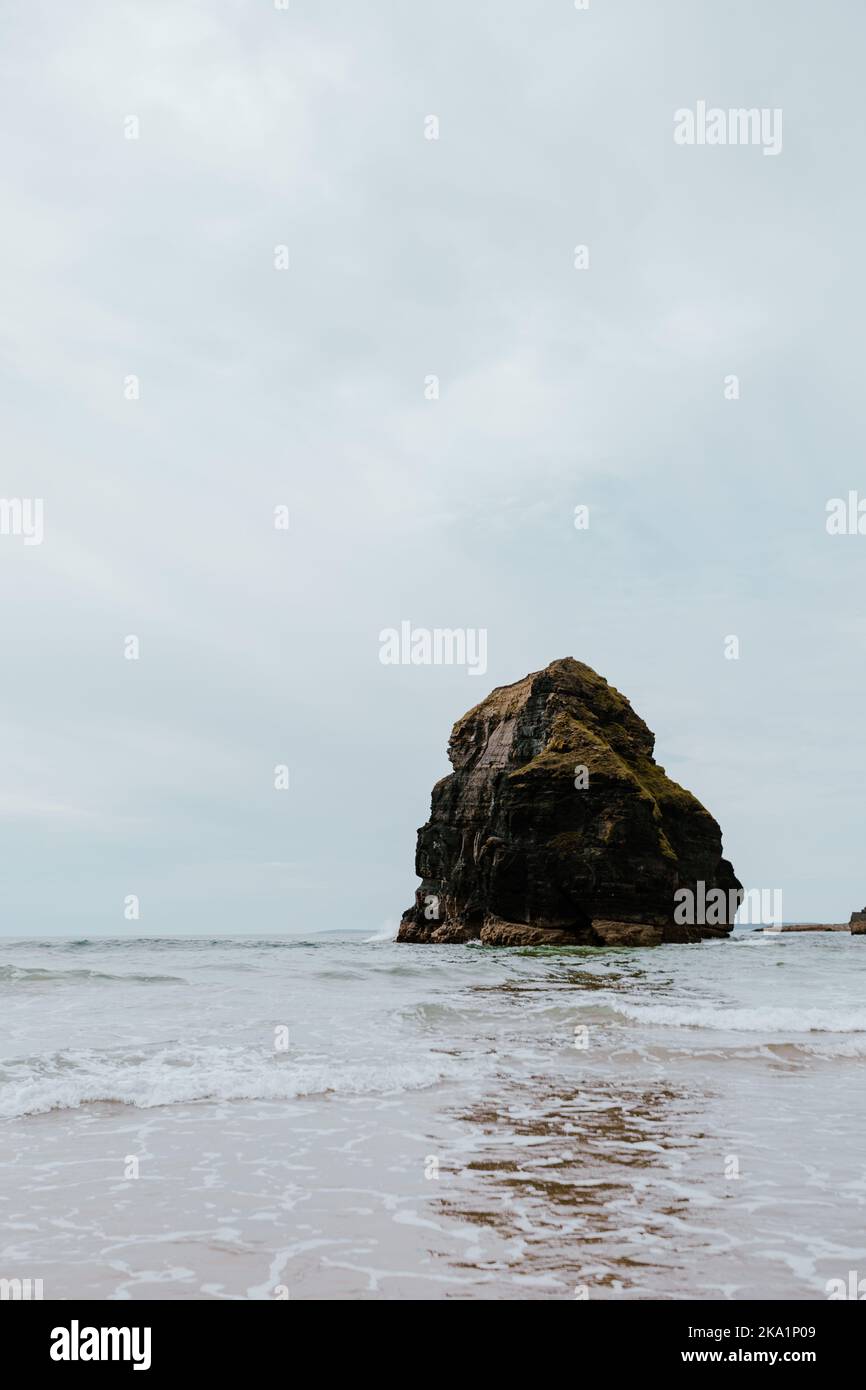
0, 922, 866, 1118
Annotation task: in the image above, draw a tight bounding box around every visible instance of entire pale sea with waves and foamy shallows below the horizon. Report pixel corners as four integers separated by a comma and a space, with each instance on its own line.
0, 930, 866, 1300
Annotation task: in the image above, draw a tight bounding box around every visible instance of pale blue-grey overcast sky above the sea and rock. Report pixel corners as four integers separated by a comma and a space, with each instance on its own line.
0, 0, 866, 935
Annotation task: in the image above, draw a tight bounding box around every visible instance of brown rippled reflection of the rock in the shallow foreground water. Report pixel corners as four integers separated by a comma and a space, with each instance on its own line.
441, 1080, 699, 1297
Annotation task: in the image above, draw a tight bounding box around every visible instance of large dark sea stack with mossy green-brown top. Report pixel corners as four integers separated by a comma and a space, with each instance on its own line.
398, 657, 741, 945
